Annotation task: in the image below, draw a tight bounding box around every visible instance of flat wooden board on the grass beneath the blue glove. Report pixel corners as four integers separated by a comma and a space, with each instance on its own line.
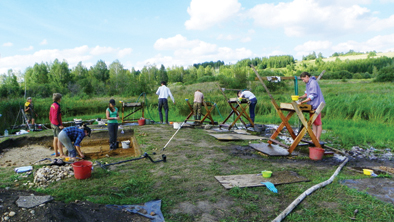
215, 171, 309, 189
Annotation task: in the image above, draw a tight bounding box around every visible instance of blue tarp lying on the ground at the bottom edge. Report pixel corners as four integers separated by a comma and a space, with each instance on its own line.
106, 200, 164, 222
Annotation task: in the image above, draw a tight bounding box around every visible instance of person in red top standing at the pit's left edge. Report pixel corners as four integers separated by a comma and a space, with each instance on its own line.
49, 93, 65, 158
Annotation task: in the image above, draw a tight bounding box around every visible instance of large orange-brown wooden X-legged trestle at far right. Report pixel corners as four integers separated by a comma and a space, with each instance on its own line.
268, 101, 325, 154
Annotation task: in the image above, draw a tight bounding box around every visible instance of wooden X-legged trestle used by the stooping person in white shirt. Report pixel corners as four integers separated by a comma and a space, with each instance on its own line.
220, 98, 254, 130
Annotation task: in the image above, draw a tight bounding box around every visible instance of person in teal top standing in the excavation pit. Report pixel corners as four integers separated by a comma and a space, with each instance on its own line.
105, 99, 119, 150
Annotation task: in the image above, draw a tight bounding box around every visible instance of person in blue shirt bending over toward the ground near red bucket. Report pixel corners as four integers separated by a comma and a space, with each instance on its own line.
58, 125, 92, 160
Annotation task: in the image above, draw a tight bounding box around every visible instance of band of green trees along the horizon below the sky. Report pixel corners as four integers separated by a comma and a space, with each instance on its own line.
0, 55, 394, 98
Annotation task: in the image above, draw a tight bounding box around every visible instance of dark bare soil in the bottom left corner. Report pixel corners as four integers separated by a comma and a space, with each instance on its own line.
0, 189, 150, 222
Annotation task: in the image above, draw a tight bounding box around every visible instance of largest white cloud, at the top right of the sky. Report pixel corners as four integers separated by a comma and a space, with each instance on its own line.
247, 0, 394, 36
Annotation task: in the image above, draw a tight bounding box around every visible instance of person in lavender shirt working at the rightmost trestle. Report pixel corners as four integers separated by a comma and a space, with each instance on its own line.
300, 72, 325, 141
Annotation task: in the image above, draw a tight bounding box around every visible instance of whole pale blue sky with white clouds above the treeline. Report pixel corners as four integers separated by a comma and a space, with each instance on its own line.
0, 0, 394, 74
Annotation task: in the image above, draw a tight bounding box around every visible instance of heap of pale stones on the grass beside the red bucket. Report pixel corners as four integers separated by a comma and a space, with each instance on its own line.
32, 165, 74, 187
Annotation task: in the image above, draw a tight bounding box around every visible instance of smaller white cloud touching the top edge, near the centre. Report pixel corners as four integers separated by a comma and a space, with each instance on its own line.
185, 0, 241, 30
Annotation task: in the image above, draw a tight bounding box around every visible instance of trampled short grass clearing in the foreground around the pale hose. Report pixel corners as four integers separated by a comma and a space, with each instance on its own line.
0, 125, 394, 222
